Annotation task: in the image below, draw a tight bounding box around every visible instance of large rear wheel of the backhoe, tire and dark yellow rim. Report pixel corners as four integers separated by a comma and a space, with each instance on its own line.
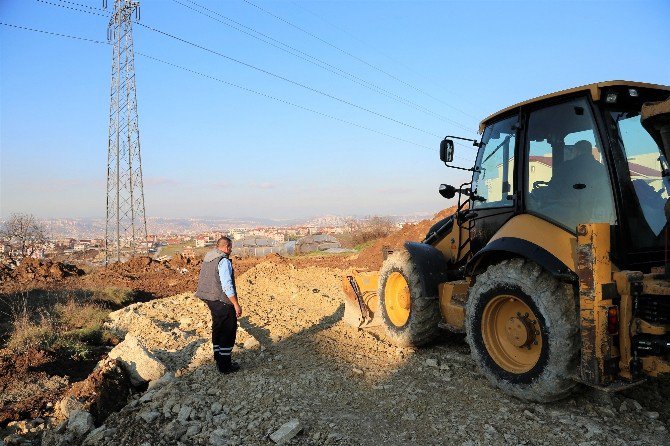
465, 259, 580, 402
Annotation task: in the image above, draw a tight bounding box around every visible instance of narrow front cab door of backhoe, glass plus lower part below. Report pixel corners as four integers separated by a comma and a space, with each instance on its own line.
470, 115, 519, 253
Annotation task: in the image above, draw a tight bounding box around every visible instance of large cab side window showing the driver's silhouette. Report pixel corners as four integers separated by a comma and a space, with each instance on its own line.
525, 98, 615, 231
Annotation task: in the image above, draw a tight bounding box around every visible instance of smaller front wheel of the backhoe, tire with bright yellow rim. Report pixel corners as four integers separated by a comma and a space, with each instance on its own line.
378, 250, 440, 347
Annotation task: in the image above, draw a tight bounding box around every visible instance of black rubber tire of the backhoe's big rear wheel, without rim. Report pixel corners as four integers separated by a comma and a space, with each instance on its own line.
465, 259, 580, 402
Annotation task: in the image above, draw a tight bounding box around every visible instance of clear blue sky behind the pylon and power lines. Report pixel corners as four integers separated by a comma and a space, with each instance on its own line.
0, 0, 670, 218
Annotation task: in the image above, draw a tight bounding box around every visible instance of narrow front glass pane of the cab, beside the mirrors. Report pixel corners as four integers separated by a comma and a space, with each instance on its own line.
472, 116, 518, 209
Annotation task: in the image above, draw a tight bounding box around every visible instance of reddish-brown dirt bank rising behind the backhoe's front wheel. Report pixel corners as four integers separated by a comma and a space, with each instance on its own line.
351, 206, 456, 270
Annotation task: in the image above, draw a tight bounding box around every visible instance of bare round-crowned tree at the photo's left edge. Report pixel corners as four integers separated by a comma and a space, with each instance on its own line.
0, 214, 47, 265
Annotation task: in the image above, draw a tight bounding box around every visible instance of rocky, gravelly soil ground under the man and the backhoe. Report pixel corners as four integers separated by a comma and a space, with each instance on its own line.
34, 259, 670, 446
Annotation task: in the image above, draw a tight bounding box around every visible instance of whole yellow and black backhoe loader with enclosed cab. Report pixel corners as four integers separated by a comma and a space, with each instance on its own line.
344, 81, 670, 402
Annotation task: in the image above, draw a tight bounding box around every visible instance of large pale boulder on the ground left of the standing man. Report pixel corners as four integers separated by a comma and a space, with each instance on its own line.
109, 334, 167, 386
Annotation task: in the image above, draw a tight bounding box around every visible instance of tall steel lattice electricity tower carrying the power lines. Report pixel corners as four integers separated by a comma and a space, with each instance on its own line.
103, 0, 147, 263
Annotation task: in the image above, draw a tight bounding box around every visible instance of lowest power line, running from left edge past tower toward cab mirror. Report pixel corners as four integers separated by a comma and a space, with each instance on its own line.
0, 18, 480, 163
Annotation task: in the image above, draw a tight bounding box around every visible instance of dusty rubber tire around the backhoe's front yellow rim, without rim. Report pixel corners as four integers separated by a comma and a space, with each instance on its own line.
378, 250, 441, 347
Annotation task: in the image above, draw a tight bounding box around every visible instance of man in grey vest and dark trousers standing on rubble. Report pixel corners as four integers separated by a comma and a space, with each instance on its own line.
195, 237, 242, 374
